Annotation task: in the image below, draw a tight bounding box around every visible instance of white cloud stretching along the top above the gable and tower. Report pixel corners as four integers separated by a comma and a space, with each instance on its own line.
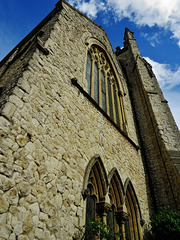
69, 0, 180, 47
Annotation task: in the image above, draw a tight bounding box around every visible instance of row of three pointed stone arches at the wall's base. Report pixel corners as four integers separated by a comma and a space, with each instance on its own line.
83, 155, 143, 240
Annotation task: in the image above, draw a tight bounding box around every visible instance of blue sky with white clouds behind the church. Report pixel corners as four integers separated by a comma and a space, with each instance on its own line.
0, 0, 180, 129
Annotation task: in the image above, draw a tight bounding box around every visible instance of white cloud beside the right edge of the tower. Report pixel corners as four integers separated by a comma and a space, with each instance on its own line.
145, 57, 180, 89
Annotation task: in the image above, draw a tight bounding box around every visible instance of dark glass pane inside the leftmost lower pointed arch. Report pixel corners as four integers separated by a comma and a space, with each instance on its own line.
85, 195, 95, 240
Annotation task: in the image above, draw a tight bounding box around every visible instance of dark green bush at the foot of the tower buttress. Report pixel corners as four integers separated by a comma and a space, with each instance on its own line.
151, 208, 180, 240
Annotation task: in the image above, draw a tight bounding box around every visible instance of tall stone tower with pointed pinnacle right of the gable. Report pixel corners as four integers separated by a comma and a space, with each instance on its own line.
118, 31, 180, 209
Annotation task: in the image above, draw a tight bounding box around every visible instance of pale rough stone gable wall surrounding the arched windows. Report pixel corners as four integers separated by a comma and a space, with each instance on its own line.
0, 0, 149, 240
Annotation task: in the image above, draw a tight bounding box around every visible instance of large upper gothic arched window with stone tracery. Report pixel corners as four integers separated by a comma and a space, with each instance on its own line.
86, 45, 125, 130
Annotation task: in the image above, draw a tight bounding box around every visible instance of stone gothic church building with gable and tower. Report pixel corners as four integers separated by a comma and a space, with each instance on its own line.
0, 0, 180, 240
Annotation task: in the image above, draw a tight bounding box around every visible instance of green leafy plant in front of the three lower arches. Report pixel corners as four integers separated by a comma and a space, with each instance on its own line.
88, 218, 121, 240
